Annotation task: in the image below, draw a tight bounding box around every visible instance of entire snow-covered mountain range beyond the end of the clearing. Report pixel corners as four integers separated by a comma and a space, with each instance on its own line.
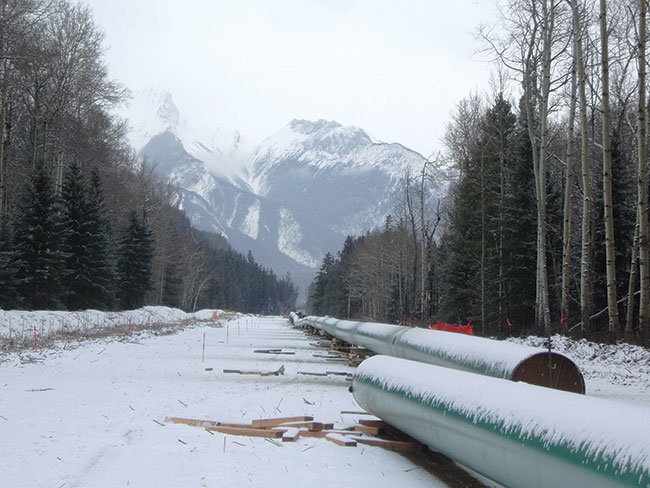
126, 90, 432, 300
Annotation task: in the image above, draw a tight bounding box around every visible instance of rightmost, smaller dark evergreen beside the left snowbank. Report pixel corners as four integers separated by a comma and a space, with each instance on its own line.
117, 211, 153, 310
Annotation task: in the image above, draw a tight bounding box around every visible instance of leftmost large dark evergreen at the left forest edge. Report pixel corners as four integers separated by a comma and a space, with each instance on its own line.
14, 164, 67, 309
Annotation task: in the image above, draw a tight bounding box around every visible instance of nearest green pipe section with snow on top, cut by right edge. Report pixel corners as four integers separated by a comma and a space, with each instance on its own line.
352, 356, 650, 488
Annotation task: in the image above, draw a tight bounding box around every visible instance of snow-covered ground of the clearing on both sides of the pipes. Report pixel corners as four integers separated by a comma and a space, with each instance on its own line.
0, 307, 650, 488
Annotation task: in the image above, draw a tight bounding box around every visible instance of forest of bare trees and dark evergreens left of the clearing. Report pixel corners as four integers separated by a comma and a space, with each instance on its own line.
0, 0, 297, 313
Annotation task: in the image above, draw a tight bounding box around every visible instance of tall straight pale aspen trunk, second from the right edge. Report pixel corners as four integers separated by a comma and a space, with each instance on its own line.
600, 0, 621, 335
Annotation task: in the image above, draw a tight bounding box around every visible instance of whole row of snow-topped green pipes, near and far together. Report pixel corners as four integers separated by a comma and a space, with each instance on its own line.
291, 314, 650, 488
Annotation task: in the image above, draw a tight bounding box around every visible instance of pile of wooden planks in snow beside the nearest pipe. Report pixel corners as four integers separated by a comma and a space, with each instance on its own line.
165, 416, 424, 452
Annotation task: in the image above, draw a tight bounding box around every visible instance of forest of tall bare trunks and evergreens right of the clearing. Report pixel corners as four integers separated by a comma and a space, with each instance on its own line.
308, 0, 650, 345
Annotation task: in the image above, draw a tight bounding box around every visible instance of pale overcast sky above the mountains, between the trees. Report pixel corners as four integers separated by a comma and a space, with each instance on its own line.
86, 0, 496, 156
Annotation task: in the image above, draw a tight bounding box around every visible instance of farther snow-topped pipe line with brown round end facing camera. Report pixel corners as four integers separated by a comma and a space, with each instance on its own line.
298, 316, 585, 393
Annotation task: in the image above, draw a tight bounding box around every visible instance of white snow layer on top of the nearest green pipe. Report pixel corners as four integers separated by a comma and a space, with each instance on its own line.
355, 356, 650, 482
